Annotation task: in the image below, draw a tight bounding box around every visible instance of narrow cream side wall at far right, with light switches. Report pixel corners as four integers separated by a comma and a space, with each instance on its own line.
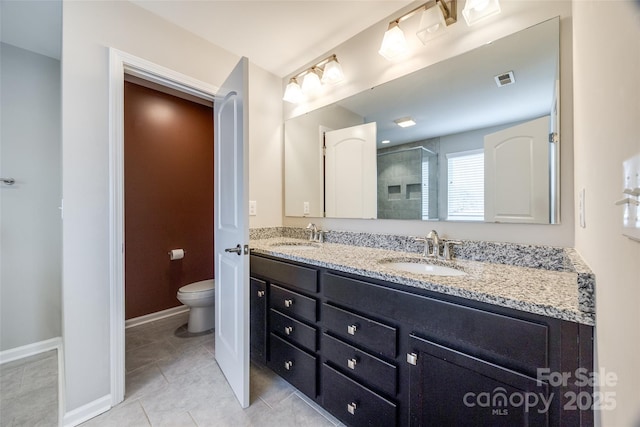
573, 0, 640, 426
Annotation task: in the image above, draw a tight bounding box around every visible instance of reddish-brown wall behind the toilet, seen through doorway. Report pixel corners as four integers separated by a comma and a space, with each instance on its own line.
124, 82, 214, 319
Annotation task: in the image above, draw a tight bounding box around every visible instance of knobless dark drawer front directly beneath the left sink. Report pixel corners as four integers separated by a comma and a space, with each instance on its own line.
250, 255, 318, 293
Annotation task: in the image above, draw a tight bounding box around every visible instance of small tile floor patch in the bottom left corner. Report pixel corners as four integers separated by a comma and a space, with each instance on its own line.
0, 350, 58, 427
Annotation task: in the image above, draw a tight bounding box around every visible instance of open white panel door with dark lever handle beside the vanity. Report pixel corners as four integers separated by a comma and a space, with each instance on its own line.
214, 58, 249, 408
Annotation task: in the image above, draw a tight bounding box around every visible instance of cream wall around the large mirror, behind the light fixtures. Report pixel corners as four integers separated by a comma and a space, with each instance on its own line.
281, 0, 574, 246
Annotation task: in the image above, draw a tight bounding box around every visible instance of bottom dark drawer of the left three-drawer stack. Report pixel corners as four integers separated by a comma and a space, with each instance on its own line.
268, 333, 316, 398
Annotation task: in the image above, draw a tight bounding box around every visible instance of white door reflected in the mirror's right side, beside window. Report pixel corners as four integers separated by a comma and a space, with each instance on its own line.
484, 116, 551, 224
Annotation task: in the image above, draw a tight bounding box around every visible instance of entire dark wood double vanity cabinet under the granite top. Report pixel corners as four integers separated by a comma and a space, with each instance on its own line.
251, 255, 593, 426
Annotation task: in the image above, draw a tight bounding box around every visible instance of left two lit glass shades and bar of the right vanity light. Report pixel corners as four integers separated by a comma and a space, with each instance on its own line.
378, 0, 458, 60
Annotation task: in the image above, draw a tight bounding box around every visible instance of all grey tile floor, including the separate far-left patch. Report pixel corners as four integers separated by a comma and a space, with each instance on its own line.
0, 313, 342, 427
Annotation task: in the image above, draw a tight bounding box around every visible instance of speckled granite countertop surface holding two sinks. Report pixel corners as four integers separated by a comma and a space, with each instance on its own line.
250, 237, 595, 325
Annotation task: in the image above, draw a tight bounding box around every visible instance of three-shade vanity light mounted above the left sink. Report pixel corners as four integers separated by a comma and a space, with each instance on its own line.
282, 55, 344, 104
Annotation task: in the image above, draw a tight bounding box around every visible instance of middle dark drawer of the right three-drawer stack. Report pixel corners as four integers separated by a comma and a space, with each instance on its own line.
322, 334, 398, 396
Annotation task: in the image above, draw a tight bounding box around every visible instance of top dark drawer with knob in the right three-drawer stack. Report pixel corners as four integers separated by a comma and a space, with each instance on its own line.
322, 304, 397, 358
